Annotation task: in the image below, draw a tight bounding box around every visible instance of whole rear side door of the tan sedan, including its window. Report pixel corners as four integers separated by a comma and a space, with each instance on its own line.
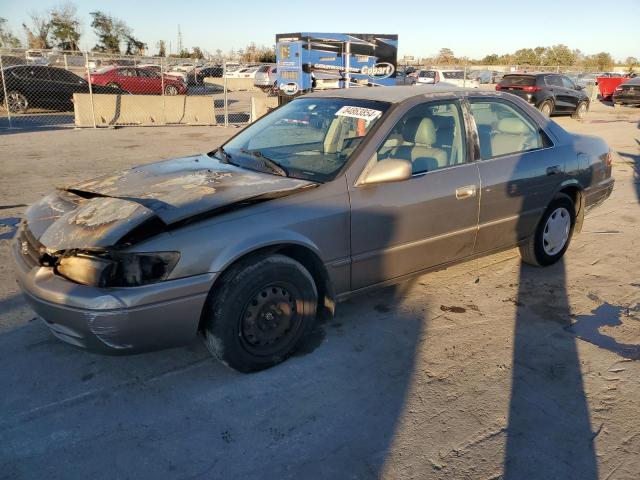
469, 97, 564, 253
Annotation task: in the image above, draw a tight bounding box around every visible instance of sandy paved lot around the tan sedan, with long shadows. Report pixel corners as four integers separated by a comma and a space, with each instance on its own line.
0, 99, 640, 480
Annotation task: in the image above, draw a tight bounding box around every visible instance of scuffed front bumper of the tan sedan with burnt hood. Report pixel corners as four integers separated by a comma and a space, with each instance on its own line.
13, 225, 215, 354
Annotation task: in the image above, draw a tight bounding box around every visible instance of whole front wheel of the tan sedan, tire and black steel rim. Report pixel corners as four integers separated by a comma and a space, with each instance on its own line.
204, 255, 318, 373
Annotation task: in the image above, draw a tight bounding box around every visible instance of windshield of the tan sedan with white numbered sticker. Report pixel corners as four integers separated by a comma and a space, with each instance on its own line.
216, 98, 389, 182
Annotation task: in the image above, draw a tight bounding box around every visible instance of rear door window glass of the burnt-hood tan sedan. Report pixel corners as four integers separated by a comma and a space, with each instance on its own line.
471, 100, 546, 160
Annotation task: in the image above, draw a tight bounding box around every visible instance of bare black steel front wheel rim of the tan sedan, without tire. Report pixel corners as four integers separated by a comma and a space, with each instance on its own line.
240, 285, 300, 355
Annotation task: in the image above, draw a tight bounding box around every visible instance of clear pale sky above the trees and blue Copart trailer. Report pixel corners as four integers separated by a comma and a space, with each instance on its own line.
0, 0, 640, 60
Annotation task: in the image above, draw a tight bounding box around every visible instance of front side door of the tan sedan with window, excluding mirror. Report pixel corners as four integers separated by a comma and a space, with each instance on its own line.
349, 100, 479, 290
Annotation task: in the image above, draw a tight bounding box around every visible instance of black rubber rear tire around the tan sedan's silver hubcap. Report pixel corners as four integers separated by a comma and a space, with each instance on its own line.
520, 193, 576, 267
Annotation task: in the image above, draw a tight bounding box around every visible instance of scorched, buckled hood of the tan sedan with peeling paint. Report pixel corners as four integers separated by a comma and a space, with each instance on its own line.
25, 155, 317, 250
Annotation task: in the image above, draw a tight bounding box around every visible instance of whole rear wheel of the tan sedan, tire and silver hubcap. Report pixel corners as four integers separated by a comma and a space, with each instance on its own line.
520, 193, 576, 267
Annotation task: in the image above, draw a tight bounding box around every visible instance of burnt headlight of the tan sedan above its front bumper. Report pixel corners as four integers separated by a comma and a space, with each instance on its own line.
55, 252, 180, 287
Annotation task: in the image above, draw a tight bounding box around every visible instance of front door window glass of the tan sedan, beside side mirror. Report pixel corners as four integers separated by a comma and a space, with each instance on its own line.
377, 101, 466, 175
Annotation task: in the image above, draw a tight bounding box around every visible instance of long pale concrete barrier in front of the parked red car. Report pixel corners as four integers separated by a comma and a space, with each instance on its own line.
73, 93, 216, 127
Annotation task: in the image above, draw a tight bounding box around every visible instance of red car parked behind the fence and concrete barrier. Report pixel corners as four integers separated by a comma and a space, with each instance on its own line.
91, 67, 187, 95
